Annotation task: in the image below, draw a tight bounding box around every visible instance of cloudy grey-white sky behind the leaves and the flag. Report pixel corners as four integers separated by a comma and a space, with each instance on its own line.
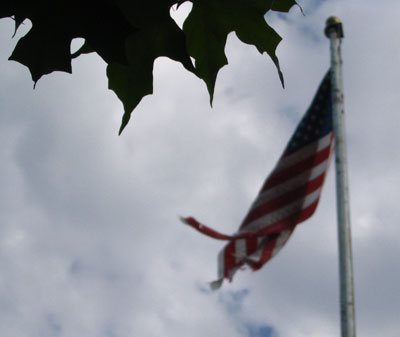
0, 0, 400, 337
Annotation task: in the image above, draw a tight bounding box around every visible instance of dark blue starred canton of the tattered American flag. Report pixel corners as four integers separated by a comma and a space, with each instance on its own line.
286, 72, 332, 154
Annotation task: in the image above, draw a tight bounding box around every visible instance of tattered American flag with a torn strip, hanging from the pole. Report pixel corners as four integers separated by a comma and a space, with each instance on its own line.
182, 72, 334, 289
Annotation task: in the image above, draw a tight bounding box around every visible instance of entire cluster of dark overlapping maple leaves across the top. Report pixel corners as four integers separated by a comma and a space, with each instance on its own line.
0, 0, 296, 133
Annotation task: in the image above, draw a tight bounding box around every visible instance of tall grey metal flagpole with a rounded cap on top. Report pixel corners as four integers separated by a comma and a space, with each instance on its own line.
325, 17, 356, 337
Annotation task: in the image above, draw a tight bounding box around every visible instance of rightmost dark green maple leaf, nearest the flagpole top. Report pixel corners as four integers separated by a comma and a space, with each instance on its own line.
183, 0, 295, 102
